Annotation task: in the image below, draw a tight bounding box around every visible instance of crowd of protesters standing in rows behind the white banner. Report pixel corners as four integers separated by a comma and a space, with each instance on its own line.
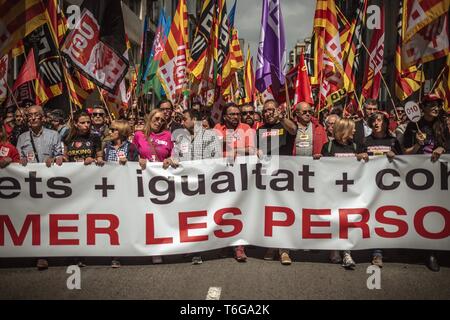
0, 94, 450, 271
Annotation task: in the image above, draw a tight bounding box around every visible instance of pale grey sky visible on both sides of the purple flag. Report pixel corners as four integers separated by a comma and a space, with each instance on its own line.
232, 0, 316, 62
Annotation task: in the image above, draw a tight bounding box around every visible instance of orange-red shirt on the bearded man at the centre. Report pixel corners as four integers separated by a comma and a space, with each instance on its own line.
214, 123, 256, 157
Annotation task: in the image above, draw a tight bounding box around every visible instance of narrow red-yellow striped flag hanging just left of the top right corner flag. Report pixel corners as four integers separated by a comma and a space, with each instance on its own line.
395, 0, 423, 101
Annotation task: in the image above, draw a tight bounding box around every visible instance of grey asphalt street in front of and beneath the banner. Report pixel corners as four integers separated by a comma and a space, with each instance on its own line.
0, 247, 450, 300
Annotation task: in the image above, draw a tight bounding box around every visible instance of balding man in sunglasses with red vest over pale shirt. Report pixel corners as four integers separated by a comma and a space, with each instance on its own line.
295, 102, 328, 157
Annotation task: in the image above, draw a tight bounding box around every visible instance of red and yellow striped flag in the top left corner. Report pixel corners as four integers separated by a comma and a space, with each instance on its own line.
0, 0, 47, 56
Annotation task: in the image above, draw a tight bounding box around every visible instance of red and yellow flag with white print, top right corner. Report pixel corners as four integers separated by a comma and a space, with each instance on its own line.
401, 0, 450, 69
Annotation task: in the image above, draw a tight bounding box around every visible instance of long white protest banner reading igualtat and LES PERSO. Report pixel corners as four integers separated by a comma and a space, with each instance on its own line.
0, 155, 450, 257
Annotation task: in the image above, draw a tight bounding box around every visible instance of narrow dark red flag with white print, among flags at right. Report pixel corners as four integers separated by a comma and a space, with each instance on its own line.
361, 1, 384, 100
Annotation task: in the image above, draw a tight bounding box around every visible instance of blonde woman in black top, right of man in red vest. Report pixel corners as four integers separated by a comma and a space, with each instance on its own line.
315, 118, 369, 269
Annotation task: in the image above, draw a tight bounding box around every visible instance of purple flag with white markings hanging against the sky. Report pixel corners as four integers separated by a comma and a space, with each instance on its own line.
256, 0, 286, 94
